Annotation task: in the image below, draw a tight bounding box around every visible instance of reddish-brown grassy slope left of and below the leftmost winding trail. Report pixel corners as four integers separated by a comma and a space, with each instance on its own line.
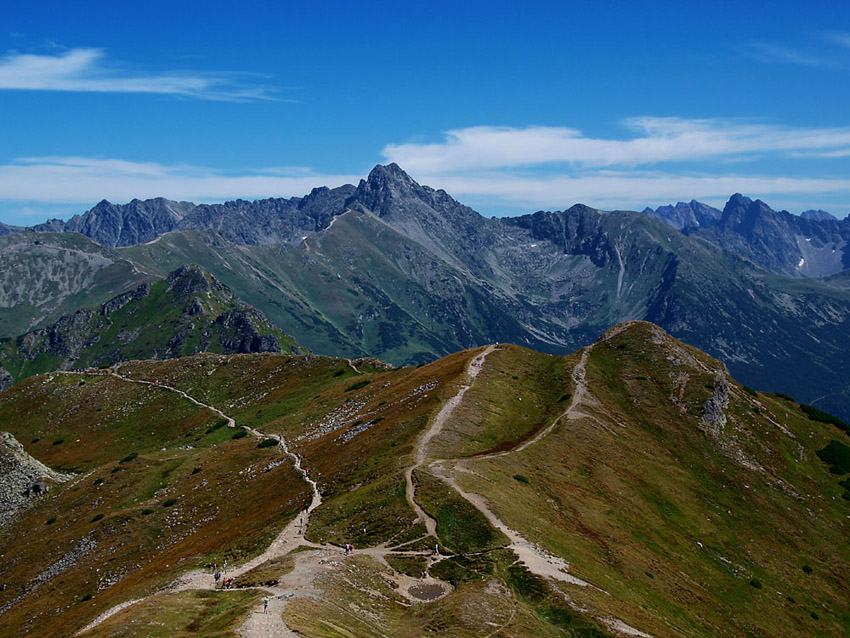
0, 368, 309, 636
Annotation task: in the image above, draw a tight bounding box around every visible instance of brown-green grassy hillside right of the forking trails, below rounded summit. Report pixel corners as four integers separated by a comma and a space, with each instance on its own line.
449, 323, 850, 636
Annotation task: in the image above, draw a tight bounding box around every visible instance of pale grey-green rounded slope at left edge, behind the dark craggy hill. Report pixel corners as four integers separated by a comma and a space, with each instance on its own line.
0, 232, 153, 337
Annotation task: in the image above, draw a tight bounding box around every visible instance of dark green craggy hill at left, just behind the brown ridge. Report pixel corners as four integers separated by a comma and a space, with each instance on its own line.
0, 266, 298, 381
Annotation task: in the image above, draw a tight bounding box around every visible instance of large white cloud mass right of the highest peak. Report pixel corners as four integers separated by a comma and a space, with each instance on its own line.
383, 117, 850, 209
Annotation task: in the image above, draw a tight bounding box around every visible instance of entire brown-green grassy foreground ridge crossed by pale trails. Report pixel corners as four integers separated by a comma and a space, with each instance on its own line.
0, 328, 850, 637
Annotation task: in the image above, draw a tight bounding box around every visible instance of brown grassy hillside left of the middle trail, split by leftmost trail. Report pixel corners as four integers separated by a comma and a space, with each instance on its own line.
0, 353, 472, 635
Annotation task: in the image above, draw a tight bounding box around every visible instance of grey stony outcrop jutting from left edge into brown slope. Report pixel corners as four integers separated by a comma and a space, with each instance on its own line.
0, 432, 71, 525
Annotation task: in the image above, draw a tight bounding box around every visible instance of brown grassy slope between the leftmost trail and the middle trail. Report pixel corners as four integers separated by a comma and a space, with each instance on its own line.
111, 350, 478, 546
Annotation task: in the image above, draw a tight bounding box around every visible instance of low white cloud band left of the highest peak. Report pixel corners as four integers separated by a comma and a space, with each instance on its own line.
0, 157, 360, 205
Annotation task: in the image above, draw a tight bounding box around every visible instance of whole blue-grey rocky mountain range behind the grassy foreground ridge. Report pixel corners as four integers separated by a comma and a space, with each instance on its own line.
3, 164, 850, 418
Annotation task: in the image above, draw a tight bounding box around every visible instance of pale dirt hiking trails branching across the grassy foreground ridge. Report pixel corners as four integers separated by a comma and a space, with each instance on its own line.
71, 330, 648, 638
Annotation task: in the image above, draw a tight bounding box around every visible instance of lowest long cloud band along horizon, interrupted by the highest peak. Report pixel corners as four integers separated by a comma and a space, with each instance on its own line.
0, 157, 850, 218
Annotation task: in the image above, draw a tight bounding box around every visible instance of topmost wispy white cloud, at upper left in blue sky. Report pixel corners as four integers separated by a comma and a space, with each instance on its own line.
0, 48, 277, 102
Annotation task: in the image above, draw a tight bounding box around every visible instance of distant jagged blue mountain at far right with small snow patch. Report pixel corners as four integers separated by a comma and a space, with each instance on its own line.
643, 194, 850, 277
